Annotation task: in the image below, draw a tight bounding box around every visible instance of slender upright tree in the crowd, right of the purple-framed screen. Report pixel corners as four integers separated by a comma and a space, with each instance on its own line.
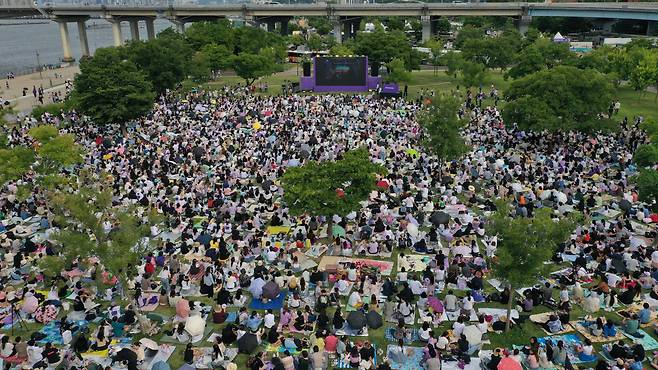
418, 94, 468, 177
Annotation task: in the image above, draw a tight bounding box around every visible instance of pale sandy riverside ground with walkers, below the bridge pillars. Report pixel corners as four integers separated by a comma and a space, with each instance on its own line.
0, 66, 80, 112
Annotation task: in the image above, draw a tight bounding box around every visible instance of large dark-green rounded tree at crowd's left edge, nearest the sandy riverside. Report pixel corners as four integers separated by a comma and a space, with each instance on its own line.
71, 48, 155, 127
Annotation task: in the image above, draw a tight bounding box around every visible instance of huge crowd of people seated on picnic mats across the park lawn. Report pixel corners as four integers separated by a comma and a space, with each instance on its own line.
0, 87, 658, 370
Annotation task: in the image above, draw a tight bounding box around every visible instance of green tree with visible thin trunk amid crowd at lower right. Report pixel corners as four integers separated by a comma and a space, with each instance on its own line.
489, 203, 576, 330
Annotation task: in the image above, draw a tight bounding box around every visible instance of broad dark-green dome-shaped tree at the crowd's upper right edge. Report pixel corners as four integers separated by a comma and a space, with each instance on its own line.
503, 66, 613, 131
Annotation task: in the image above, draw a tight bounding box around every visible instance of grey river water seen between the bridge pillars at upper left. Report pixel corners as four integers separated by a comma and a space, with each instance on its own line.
0, 19, 173, 78
